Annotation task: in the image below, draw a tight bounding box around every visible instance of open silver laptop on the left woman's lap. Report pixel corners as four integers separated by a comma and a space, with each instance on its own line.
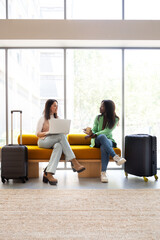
49, 118, 71, 134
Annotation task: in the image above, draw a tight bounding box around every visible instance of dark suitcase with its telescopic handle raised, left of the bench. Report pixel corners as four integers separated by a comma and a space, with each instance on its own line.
1, 110, 28, 183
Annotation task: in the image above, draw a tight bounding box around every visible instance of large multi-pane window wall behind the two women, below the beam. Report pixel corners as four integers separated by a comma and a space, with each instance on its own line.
0, 48, 160, 167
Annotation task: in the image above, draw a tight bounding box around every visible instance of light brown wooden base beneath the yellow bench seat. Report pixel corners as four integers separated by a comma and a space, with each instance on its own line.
28, 159, 112, 178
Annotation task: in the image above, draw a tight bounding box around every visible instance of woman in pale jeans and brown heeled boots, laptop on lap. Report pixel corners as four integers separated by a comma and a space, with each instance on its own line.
36, 99, 85, 185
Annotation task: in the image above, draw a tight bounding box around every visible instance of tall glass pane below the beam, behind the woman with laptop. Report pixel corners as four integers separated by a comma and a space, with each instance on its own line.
8, 49, 64, 142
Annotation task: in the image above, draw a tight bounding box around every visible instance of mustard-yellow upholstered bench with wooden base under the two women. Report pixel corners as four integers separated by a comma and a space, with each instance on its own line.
18, 134, 121, 178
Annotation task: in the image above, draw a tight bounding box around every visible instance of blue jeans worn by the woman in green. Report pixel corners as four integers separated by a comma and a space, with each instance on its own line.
95, 134, 116, 172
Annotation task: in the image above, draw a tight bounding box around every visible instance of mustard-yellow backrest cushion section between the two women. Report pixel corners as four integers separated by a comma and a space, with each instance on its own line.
67, 134, 91, 145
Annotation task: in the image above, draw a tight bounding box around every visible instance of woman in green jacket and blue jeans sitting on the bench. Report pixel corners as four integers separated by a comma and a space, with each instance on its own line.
84, 100, 126, 183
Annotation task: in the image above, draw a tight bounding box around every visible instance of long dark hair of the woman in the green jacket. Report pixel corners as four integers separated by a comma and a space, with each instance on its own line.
99, 100, 119, 129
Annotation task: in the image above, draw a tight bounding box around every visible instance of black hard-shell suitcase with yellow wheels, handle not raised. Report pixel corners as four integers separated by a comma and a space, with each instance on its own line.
125, 134, 158, 182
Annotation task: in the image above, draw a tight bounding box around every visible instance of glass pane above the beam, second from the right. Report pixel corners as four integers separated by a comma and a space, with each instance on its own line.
67, 0, 122, 19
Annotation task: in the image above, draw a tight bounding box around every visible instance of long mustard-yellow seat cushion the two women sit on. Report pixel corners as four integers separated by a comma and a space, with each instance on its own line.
27, 145, 121, 160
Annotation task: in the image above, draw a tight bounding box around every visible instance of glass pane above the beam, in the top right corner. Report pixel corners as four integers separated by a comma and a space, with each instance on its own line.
125, 0, 160, 20
